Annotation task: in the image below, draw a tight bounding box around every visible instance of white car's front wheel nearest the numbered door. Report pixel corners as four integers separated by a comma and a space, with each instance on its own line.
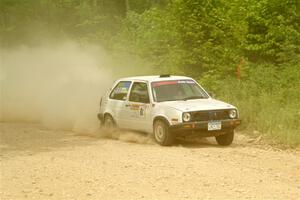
153, 120, 174, 146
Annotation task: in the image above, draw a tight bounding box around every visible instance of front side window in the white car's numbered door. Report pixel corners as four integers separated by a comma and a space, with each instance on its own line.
129, 82, 150, 103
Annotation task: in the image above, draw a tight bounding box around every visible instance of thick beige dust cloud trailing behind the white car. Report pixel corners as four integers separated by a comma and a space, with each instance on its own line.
0, 42, 152, 143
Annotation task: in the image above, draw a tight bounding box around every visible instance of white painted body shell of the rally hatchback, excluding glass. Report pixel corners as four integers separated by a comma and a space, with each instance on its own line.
100, 76, 237, 133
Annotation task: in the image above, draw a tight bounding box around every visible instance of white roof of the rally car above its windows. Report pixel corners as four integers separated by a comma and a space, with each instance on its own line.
118, 75, 192, 82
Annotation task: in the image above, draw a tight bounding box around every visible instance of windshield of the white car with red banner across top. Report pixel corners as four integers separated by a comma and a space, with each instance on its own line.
151, 80, 208, 102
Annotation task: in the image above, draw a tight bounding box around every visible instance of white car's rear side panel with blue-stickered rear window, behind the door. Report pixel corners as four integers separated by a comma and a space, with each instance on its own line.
106, 81, 132, 128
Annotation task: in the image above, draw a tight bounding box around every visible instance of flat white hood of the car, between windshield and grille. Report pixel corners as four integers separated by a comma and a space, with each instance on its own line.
162, 98, 235, 112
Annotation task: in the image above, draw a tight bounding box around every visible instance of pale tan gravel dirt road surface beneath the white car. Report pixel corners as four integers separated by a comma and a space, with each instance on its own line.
0, 123, 300, 200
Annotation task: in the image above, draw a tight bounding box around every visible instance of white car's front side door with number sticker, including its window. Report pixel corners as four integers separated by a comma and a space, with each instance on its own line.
127, 81, 152, 132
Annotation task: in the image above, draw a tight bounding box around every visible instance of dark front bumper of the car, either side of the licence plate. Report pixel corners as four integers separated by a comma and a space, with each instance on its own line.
170, 119, 241, 132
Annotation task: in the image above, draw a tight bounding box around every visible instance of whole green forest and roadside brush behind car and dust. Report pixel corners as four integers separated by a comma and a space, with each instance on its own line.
0, 0, 300, 146
